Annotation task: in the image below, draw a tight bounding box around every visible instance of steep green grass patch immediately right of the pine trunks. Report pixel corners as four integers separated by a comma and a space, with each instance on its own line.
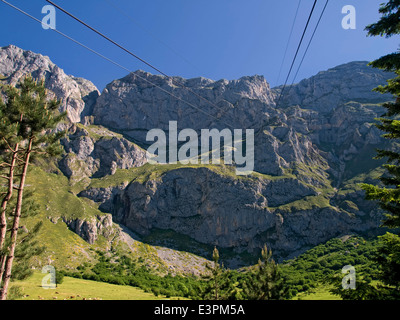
23, 166, 104, 269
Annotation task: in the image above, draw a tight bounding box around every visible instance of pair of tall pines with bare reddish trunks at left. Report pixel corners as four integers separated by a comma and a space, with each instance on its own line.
0, 76, 65, 300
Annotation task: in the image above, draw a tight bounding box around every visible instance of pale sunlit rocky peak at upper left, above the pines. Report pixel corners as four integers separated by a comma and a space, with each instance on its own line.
0, 45, 100, 122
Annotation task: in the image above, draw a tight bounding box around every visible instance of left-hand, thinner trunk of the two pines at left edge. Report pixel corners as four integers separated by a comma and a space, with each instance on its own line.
0, 143, 19, 286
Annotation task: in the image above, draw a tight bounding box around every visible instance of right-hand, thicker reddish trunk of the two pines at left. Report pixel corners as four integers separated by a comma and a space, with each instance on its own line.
0, 137, 33, 300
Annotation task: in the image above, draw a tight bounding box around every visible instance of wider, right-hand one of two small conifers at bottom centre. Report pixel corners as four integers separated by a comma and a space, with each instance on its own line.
245, 245, 284, 300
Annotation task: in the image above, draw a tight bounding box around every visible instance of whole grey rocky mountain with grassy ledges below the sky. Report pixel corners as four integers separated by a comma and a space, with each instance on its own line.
0, 46, 392, 265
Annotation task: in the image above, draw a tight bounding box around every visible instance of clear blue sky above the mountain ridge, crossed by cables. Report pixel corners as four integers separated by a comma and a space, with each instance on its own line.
0, 0, 399, 90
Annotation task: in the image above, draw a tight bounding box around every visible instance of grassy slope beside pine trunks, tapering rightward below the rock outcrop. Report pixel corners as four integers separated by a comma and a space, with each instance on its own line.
22, 166, 209, 274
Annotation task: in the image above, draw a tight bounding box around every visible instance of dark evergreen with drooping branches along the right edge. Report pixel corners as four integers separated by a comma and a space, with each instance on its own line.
352, 0, 400, 299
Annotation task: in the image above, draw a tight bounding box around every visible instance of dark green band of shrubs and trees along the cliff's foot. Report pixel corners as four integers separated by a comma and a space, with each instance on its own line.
61, 232, 390, 300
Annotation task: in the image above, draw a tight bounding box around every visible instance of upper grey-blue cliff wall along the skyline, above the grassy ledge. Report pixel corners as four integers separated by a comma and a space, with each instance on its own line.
92, 62, 391, 185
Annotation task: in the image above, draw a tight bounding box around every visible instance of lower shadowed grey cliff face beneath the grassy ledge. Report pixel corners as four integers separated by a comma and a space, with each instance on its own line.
112, 168, 315, 250
